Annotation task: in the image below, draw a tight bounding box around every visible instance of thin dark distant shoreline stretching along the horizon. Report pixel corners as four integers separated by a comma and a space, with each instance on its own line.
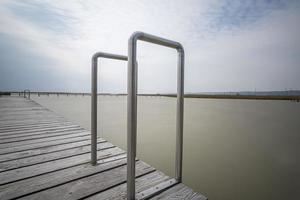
0, 91, 300, 102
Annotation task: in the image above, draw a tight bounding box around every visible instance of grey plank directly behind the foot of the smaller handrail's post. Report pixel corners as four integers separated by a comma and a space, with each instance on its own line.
0, 147, 125, 185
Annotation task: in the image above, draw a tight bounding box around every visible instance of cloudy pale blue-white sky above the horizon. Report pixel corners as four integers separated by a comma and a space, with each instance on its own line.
0, 0, 300, 93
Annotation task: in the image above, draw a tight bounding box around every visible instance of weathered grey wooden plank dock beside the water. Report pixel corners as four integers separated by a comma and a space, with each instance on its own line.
0, 97, 206, 200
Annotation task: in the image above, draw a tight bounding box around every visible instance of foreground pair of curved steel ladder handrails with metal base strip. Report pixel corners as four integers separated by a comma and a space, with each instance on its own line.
91, 32, 184, 200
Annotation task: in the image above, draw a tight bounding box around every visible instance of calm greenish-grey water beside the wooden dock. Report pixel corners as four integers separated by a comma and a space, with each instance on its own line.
33, 96, 300, 200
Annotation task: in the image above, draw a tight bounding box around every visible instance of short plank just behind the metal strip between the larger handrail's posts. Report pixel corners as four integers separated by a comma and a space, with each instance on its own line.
85, 171, 170, 200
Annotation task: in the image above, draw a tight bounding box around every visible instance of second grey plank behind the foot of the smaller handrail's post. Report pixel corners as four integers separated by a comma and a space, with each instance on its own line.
0, 142, 114, 173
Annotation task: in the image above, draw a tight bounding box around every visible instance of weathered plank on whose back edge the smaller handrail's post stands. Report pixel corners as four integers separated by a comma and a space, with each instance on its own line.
0, 154, 126, 200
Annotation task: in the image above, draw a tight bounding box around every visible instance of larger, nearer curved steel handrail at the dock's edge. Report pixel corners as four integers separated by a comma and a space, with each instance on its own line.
127, 32, 184, 200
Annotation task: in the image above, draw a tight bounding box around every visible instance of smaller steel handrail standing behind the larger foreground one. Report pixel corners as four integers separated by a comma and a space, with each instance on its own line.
91, 52, 127, 165
